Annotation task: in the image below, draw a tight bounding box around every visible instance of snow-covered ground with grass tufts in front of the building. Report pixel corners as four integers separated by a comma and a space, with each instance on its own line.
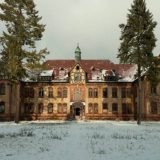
0, 121, 160, 160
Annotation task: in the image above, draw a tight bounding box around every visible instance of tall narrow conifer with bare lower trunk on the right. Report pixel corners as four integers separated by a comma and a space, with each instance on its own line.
117, 0, 157, 124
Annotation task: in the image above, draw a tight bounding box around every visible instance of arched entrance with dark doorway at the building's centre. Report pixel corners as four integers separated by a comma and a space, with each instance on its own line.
70, 102, 85, 120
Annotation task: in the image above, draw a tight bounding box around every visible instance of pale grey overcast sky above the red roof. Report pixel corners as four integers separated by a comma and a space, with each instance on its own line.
18, 0, 160, 62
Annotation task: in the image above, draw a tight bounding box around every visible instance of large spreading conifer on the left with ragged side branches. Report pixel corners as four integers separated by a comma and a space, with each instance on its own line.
0, 0, 47, 121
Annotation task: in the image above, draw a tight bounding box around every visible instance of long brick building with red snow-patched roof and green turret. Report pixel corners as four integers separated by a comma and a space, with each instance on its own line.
0, 47, 160, 121
